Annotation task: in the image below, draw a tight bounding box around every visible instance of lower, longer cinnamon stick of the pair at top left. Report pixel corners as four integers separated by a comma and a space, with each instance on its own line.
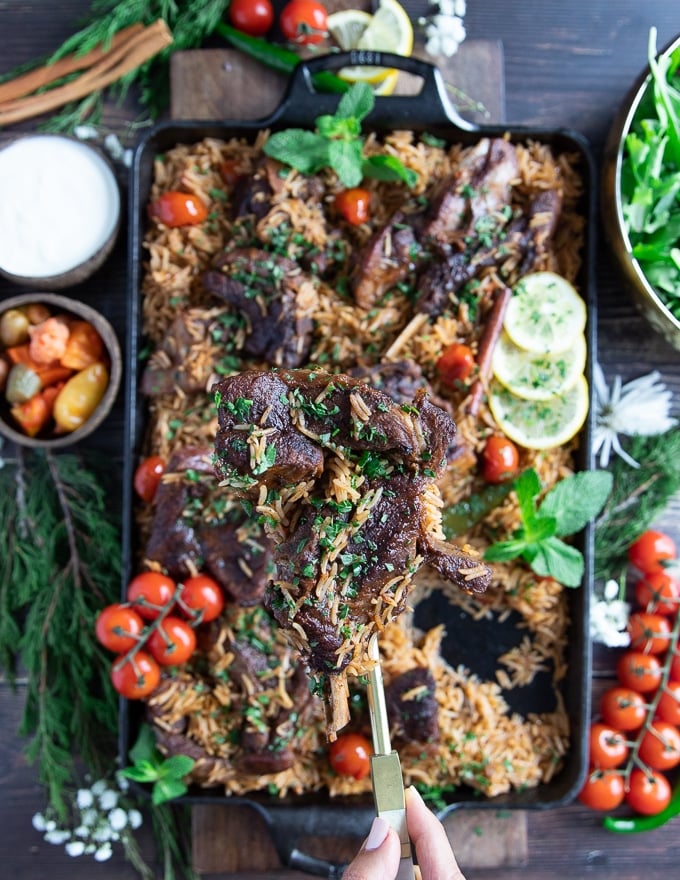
0, 19, 172, 127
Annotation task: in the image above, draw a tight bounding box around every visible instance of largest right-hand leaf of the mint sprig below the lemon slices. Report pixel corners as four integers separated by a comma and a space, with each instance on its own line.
538, 471, 613, 536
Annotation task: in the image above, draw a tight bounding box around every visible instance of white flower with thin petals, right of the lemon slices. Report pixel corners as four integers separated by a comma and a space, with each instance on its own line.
593, 364, 677, 468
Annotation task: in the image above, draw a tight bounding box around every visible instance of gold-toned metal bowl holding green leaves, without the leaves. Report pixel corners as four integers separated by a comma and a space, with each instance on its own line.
601, 37, 680, 350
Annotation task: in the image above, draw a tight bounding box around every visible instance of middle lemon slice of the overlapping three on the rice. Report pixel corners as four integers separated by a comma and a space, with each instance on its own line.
491, 332, 587, 400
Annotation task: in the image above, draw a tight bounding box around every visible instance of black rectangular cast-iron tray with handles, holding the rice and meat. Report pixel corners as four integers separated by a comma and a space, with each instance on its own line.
120, 52, 597, 877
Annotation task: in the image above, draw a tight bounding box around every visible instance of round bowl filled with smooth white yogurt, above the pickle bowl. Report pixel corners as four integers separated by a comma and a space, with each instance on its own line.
0, 134, 121, 290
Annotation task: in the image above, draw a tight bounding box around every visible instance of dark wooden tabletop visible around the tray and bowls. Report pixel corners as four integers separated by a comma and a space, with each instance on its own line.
0, 0, 680, 880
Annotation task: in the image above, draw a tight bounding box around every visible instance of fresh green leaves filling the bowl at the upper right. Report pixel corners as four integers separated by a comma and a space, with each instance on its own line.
621, 28, 680, 318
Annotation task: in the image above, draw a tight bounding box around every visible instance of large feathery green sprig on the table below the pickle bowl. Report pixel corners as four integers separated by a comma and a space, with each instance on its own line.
0, 451, 121, 815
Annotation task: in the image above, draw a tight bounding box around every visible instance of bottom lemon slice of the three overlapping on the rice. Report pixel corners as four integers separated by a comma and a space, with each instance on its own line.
489, 376, 588, 449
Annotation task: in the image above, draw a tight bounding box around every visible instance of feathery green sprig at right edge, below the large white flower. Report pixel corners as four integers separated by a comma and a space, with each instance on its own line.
595, 428, 680, 580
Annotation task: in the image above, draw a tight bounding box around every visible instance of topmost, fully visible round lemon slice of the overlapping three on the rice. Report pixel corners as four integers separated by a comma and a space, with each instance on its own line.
503, 272, 586, 353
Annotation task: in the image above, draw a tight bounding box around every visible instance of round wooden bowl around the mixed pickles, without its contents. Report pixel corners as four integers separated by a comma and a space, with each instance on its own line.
0, 292, 122, 449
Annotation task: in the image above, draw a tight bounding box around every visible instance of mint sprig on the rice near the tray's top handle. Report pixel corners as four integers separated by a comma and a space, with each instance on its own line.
264, 83, 418, 187
